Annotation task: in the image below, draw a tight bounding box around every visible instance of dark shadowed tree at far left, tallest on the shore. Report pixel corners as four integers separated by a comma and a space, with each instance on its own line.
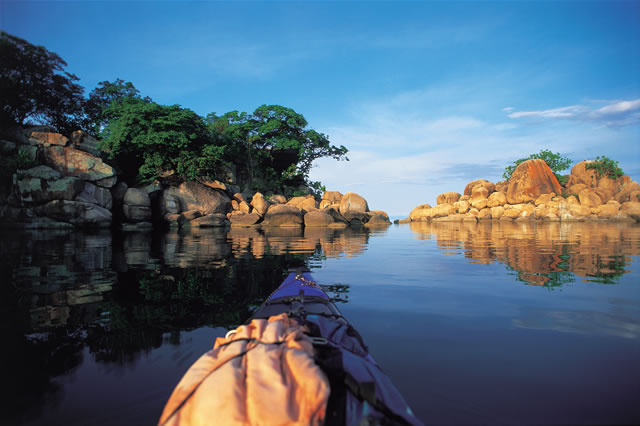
0, 31, 84, 133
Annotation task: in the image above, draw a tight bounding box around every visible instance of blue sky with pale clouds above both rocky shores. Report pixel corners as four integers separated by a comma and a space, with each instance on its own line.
0, 0, 640, 216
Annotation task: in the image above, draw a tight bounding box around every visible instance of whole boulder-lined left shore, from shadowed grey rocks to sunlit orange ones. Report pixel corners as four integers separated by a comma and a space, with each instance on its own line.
0, 129, 391, 230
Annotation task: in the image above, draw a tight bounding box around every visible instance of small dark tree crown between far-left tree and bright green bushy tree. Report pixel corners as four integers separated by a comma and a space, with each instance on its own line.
84, 78, 151, 135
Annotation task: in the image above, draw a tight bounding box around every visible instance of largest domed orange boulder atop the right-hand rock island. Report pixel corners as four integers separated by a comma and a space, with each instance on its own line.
507, 159, 562, 204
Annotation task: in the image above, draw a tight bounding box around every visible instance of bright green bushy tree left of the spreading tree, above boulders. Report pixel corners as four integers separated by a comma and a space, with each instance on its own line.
100, 97, 225, 182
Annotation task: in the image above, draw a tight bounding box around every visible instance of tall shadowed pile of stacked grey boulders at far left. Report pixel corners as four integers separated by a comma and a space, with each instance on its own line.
0, 130, 117, 228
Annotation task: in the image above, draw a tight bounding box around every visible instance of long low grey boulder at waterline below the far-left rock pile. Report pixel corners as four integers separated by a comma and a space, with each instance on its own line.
34, 200, 111, 227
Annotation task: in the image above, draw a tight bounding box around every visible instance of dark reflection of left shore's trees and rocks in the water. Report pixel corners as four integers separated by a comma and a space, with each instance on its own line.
0, 228, 369, 422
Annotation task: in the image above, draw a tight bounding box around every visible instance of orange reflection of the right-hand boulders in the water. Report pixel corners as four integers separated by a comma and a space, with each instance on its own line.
409, 222, 640, 287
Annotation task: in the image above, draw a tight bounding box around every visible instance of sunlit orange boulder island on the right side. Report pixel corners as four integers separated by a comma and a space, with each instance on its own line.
399, 159, 640, 223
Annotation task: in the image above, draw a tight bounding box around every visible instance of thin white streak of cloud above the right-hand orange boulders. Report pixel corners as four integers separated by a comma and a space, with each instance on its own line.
504, 99, 640, 127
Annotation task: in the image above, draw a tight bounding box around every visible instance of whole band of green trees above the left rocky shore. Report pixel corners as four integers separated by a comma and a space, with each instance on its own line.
0, 31, 348, 196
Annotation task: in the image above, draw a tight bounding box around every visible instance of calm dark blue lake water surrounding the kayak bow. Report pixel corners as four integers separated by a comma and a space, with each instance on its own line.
0, 223, 640, 425
